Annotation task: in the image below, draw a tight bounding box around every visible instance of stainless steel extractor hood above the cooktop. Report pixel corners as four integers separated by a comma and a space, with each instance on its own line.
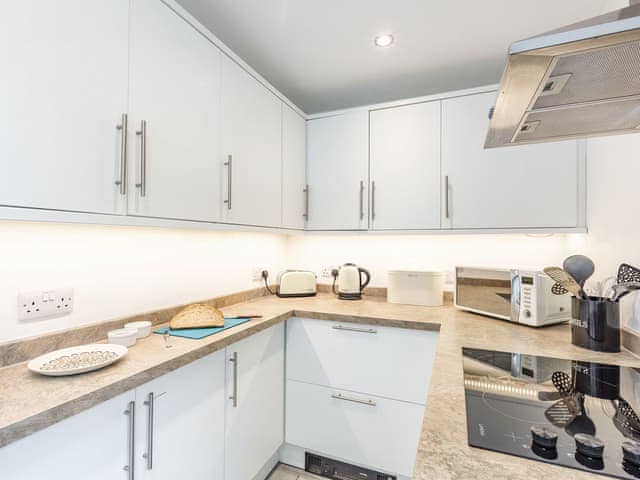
485, 1, 640, 148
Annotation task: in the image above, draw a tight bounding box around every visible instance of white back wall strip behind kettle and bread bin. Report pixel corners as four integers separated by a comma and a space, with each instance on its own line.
288, 234, 567, 289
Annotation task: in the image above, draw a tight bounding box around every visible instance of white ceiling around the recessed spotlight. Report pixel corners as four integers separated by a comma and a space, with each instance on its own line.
178, 0, 611, 113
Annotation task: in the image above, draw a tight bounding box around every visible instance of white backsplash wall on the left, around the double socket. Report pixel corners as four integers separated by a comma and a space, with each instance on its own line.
0, 222, 286, 342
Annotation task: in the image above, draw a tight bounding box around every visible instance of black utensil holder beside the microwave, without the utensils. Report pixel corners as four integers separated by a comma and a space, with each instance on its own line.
571, 297, 620, 352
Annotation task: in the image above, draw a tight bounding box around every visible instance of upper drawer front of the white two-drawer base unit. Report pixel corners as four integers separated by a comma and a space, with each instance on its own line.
287, 318, 438, 405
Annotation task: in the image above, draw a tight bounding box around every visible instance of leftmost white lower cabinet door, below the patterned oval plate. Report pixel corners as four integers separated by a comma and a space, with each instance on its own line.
0, 391, 135, 480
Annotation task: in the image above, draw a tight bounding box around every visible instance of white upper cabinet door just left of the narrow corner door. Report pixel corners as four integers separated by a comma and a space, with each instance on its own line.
221, 57, 282, 227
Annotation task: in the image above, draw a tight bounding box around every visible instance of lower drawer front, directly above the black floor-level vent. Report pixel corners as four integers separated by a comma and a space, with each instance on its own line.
286, 380, 424, 477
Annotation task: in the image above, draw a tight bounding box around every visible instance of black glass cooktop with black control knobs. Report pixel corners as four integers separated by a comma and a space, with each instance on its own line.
462, 348, 640, 479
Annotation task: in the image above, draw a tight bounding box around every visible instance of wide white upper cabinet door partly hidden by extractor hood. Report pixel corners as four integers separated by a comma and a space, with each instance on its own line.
442, 93, 581, 229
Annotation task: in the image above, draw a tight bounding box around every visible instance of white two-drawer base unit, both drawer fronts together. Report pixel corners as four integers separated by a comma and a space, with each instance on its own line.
283, 318, 438, 477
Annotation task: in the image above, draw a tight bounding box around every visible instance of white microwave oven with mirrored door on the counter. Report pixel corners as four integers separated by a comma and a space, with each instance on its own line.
454, 267, 571, 327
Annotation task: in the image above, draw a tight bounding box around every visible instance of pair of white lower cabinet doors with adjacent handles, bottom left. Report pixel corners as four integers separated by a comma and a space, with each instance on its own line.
0, 351, 225, 480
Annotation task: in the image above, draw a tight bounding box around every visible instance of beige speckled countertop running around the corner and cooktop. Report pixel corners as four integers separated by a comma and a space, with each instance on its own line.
0, 294, 640, 480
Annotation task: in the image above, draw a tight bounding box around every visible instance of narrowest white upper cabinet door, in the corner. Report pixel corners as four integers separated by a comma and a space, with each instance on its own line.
282, 104, 307, 229
